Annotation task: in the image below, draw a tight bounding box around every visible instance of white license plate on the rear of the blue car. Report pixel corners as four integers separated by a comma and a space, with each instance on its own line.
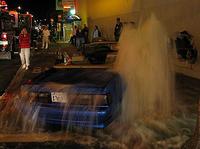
51, 92, 67, 103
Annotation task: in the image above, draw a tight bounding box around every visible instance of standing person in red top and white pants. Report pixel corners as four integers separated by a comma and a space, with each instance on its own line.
19, 27, 30, 70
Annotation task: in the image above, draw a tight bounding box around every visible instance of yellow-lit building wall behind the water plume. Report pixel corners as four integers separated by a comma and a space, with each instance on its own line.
78, 0, 200, 48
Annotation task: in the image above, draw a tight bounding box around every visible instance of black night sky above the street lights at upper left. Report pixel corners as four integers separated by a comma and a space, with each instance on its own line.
6, 0, 55, 19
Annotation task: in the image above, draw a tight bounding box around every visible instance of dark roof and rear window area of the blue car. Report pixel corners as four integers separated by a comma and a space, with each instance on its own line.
33, 68, 118, 87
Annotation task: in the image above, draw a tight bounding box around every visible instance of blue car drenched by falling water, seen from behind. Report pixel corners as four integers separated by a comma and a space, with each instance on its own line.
21, 68, 122, 128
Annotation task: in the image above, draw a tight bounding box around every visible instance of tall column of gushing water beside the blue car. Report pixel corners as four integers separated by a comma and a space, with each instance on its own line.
114, 15, 174, 123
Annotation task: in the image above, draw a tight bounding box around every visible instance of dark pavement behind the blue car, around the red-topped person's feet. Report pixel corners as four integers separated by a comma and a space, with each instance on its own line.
0, 43, 76, 95
